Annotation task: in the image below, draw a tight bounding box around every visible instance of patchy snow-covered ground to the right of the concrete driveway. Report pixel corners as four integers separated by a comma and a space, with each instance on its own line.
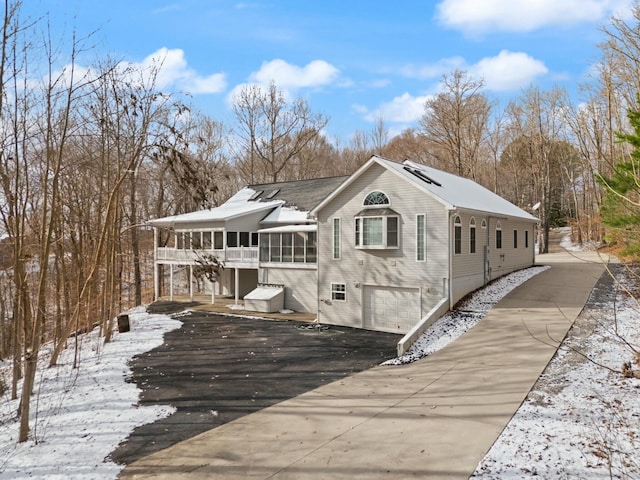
471, 262, 640, 480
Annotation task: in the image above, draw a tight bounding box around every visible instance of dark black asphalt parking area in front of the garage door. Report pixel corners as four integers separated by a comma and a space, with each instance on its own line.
110, 302, 400, 464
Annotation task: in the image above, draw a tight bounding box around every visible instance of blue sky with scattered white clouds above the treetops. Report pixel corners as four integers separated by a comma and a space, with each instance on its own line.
22, 0, 632, 145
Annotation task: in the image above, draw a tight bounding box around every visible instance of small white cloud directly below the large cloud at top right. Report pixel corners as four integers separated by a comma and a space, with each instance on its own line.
469, 50, 549, 92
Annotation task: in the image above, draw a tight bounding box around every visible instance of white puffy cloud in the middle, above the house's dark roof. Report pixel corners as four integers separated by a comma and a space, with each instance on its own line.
249, 59, 340, 89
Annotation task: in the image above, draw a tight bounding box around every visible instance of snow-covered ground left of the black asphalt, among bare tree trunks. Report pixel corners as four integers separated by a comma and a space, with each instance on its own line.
0, 308, 181, 480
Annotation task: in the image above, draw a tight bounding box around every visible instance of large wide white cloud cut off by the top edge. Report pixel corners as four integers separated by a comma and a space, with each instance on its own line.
436, 0, 633, 33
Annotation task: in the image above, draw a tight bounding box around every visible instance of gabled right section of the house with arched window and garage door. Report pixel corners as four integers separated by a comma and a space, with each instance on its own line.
311, 156, 538, 350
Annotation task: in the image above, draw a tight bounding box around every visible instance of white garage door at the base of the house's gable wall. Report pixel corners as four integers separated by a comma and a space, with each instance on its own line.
363, 286, 420, 333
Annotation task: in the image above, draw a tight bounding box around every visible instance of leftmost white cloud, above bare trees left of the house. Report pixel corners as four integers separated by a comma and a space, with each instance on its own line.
140, 47, 227, 95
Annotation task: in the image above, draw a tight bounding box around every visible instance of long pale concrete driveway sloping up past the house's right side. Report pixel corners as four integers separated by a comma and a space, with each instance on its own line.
121, 253, 604, 480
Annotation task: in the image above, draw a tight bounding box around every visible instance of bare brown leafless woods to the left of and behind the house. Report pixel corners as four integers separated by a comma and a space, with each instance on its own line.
0, 0, 640, 441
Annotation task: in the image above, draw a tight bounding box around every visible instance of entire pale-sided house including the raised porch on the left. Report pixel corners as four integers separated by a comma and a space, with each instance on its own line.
150, 156, 538, 353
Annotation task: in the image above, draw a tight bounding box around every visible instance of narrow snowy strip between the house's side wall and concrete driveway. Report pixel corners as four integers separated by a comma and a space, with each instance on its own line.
383, 265, 549, 365
